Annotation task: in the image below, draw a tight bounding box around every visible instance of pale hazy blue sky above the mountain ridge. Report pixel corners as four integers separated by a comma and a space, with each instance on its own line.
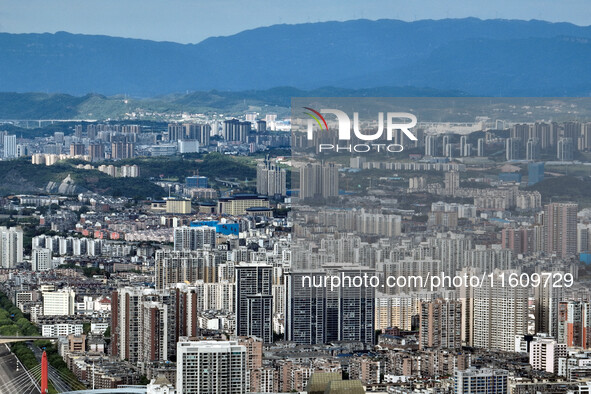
0, 0, 591, 43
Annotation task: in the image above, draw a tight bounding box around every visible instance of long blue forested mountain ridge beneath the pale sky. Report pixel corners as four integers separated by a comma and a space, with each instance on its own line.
0, 18, 591, 97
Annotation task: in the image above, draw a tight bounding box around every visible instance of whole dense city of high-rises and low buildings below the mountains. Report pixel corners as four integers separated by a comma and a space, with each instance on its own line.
0, 106, 591, 394
